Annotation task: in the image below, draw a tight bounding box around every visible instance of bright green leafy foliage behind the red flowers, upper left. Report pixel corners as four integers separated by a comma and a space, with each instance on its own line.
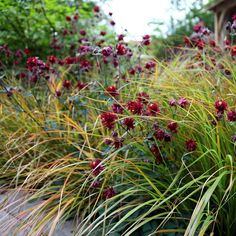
0, 0, 94, 58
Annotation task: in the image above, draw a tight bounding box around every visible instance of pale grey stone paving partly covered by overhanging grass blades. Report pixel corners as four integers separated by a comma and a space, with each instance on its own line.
0, 190, 75, 236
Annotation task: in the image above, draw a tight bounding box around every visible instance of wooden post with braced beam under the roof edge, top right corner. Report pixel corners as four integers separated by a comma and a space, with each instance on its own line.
208, 0, 236, 45
